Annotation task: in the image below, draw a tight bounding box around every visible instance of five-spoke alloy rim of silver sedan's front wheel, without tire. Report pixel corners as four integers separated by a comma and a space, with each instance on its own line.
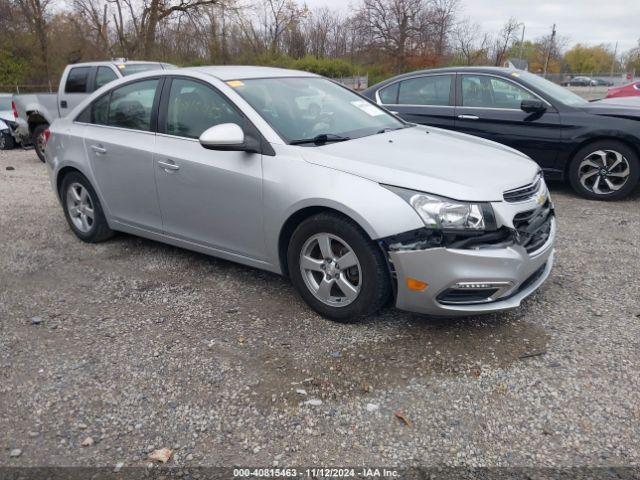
300, 233, 362, 307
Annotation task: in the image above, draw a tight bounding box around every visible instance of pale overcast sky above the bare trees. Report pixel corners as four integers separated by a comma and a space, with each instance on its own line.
298, 0, 640, 52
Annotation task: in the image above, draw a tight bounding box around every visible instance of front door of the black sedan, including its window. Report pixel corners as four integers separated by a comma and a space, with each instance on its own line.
455, 74, 562, 168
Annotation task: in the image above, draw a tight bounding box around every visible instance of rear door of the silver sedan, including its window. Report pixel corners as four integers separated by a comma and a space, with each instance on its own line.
81, 78, 162, 233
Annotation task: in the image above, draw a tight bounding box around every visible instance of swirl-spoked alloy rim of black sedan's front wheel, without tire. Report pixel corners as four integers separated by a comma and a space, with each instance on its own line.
578, 150, 631, 195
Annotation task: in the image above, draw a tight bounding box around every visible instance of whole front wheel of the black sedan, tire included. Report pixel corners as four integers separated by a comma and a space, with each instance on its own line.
569, 140, 640, 200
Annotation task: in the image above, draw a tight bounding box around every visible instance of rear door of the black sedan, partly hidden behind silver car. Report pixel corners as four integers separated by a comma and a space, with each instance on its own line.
376, 74, 456, 128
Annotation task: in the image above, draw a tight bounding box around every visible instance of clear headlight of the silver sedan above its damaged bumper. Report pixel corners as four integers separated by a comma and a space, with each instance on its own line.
385, 186, 496, 231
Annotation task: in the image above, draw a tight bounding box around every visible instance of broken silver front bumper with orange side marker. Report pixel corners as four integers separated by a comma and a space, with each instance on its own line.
383, 212, 556, 316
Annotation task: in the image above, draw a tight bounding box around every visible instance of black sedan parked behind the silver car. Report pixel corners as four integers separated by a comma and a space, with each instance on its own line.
363, 67, 640, 200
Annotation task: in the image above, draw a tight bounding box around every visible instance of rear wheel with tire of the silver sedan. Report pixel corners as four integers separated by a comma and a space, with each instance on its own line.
60, 172, 114, 243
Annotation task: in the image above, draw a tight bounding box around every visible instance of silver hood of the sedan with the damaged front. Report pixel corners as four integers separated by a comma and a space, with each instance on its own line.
300, 126, 540, 201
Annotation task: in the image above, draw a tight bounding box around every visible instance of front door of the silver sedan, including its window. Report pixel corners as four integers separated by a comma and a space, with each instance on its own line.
154, 77, 266, 259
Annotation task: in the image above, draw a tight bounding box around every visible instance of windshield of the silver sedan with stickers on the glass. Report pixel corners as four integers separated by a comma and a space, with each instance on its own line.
227, 77, 407, 145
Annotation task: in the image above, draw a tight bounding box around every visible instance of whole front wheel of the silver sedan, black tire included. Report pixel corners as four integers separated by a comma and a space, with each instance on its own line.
287, 213, 391, 323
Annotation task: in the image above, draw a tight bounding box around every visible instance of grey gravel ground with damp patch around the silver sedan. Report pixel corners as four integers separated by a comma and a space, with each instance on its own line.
0, 151, 640, 467
